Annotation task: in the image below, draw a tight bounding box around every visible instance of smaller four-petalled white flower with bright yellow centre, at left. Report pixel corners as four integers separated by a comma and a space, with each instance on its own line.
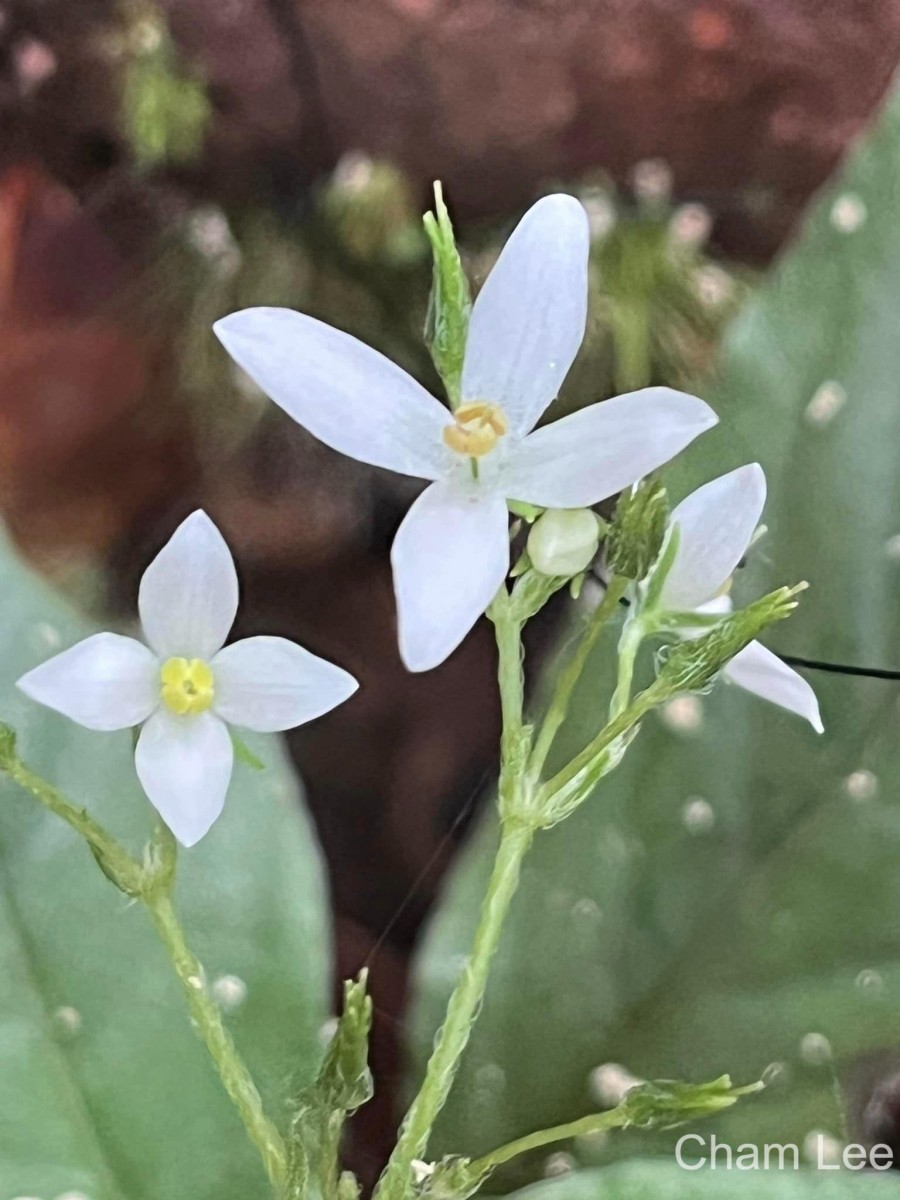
18, 512, 358, 846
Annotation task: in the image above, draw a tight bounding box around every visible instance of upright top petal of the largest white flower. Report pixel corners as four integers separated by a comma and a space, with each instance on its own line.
462, 196, 590, 437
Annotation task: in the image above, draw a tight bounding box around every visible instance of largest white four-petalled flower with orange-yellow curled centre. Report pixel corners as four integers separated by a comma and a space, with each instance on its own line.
215, 196, 716, 671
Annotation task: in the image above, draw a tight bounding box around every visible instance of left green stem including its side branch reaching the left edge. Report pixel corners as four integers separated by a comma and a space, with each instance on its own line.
0, 752, 287, 1194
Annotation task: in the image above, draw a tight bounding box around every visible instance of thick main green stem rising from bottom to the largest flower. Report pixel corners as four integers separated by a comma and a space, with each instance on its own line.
377, 588, 534, 1200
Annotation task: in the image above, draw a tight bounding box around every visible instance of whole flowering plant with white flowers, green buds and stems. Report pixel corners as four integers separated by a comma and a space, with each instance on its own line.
0, 193, 822, 1200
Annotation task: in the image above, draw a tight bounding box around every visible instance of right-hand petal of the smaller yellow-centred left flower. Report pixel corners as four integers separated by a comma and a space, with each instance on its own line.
211, 637, 359, 733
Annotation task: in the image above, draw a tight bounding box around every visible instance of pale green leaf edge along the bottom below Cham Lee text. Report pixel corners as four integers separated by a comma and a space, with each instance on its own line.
515, 1159, 900, 1200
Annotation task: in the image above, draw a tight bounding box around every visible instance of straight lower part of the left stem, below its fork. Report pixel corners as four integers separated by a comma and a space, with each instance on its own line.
146, 896, 287, 1194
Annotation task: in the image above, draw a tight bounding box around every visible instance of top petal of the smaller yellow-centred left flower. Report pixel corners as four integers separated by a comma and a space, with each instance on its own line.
138, 511, 238, 659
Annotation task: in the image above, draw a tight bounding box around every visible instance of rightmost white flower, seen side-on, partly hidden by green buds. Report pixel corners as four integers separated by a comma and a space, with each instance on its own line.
659, 463, 823, 733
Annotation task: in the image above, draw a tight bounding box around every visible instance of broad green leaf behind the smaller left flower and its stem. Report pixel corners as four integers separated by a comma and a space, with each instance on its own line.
0, 530, 329, 1200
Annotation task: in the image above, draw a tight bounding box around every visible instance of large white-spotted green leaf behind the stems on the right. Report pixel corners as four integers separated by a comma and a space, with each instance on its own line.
412, 84, 900, 1194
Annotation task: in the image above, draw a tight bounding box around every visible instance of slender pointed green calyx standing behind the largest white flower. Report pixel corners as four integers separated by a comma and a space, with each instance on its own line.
424, 184, 472, 408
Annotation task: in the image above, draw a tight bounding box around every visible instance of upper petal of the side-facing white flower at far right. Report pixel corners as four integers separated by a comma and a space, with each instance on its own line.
660, 462, 766, 612
